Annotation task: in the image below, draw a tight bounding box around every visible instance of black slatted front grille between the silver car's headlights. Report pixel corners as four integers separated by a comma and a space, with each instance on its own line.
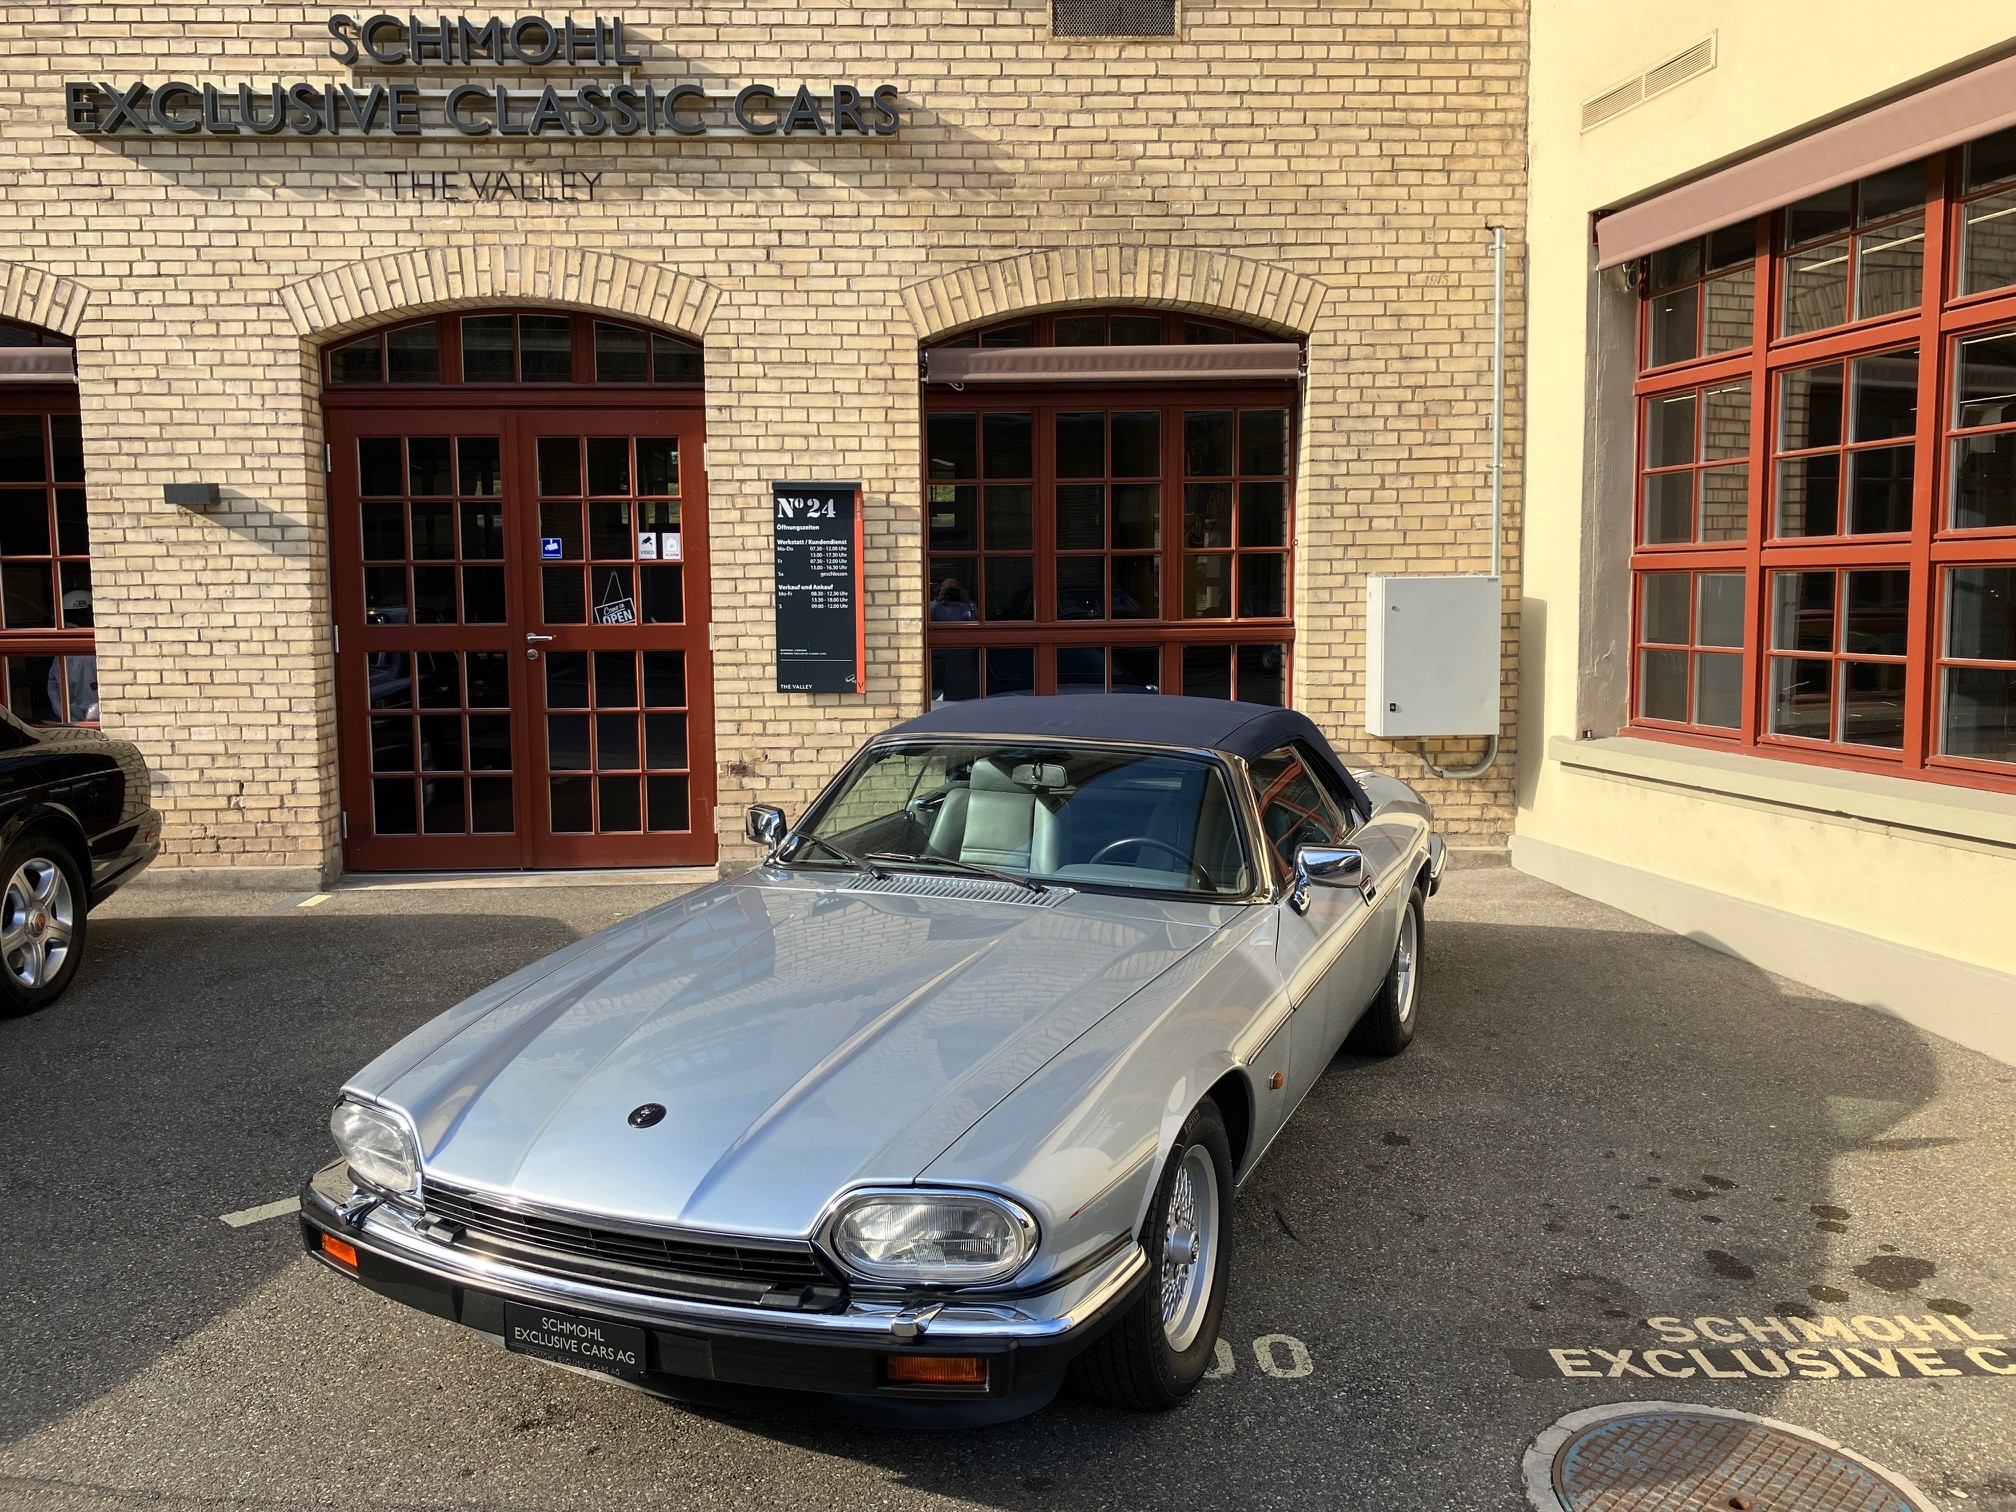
425, 1181, 839, 1306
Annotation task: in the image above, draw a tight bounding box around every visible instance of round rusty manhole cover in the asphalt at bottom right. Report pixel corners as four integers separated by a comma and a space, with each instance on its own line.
1526, 1401, 1931, 1512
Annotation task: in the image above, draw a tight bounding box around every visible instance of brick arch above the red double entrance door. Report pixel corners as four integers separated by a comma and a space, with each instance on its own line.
280, 246, 720, 341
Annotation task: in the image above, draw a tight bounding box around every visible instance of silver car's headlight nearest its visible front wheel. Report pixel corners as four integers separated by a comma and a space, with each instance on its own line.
831, 1191, 1036, 1286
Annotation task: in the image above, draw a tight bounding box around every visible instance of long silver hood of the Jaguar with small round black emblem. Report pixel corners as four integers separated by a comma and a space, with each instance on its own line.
351, 873, 1230, 1236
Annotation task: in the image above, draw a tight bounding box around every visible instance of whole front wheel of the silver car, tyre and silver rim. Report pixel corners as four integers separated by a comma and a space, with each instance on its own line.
1077, 1101, 1232, 1411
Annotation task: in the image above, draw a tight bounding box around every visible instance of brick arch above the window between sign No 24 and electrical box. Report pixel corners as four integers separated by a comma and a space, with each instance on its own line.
903, 246, 1331, 341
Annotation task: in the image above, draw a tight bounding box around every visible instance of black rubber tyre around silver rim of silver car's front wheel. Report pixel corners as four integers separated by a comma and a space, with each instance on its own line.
1073, 1099, 1232, 1413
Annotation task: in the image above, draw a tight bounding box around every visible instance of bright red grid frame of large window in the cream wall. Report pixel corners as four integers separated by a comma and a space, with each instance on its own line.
1627, 149, 2016, 792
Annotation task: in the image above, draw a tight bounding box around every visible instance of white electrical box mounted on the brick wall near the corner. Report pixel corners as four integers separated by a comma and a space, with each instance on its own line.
1365, 573, 1504, 736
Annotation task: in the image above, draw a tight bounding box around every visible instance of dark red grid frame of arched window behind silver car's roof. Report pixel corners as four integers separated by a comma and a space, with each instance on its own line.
921, 306, 1300, 706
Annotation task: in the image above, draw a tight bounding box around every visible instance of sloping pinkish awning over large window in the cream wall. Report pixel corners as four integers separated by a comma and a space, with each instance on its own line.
1597, 56, 2016, 268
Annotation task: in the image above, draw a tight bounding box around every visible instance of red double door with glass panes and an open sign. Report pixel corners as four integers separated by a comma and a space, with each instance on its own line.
329, 399, 714, 871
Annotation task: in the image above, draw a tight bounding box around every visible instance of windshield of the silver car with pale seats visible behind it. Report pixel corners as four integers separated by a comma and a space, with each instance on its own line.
784, 740, 1252, 897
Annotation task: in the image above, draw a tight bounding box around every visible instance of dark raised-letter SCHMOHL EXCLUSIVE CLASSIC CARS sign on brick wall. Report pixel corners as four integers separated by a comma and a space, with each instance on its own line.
62, 14, 903, 139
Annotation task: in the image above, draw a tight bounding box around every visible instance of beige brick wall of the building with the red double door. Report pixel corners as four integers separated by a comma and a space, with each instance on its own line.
0, 0, 1526, 865
